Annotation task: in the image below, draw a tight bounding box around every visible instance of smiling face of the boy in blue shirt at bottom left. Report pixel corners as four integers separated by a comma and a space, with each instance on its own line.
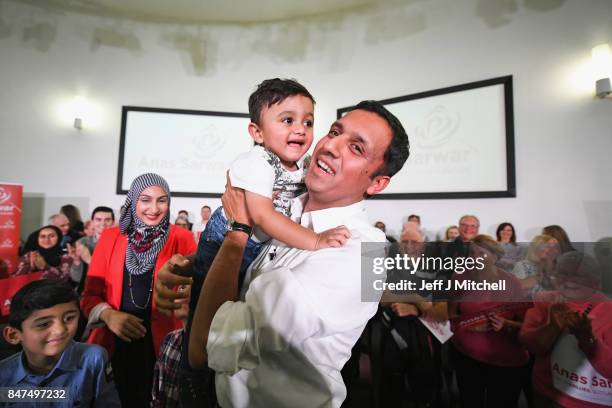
11, 302, 79, 361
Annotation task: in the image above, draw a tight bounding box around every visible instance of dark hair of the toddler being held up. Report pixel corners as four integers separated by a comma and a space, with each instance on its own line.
249, 78, 315, 125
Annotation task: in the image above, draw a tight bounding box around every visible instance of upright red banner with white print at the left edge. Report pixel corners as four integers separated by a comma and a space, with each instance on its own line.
0, 183, 23, 279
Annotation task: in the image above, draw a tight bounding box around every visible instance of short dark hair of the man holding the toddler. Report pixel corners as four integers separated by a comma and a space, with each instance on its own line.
352, 101, 410, 178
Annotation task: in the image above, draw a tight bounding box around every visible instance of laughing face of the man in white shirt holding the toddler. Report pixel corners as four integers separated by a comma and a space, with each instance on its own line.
305, 110, 392, 211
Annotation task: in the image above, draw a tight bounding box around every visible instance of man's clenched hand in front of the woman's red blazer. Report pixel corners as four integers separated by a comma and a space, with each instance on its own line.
153, 254, 194, 316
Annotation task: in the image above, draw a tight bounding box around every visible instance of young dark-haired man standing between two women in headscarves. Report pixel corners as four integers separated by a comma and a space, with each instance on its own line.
70, 206, 115, 293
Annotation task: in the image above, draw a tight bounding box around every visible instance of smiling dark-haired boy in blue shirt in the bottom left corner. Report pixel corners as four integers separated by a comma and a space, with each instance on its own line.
0, 279, 121, 407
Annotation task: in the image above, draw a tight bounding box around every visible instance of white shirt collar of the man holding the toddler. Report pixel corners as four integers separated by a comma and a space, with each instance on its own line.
292, 194, 365, 233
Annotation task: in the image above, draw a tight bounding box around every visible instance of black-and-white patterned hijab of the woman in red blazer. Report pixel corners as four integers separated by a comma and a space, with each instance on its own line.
119, 173, 170, 275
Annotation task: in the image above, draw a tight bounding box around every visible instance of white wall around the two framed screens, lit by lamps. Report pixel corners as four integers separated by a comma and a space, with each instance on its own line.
0, 0, 612, 240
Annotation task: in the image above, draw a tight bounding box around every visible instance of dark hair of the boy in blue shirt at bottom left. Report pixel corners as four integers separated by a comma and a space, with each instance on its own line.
9, 279, 79, 330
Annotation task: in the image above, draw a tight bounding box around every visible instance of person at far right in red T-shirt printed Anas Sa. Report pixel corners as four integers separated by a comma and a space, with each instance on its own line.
519, 251, 612, 408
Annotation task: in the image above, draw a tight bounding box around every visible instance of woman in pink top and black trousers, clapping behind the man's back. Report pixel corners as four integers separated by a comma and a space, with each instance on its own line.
449, 234, 529, 408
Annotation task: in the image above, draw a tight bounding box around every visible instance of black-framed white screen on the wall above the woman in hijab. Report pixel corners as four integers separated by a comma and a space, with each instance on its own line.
117, 106, 253, 197
